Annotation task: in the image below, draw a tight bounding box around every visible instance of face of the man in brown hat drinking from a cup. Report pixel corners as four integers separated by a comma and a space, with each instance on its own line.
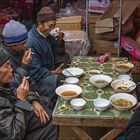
38, 20, 56, 36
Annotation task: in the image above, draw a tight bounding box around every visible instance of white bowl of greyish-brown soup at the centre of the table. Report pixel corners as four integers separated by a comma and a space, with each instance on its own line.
89, 74, 112, 88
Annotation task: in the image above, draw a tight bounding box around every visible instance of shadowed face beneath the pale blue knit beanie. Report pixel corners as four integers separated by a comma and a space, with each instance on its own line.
8, 41, 27, 53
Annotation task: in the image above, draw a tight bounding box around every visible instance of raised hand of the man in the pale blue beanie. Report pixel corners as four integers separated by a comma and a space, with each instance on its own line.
22, 48, 32, 65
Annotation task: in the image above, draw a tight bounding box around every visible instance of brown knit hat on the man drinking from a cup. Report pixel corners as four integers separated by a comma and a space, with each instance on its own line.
37, 6, 56, 22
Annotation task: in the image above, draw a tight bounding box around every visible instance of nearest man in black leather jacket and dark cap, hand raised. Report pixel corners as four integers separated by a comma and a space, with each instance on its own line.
0, 48, 57, 140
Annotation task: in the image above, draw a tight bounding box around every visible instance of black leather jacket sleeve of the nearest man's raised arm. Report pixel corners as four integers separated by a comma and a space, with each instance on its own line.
0, 98, 31, 140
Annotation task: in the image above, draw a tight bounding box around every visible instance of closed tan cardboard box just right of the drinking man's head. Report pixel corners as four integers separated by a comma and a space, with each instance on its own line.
56, 16, 82, 30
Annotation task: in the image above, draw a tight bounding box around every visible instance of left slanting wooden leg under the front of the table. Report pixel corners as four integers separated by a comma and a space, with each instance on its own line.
70, 126, 92, 140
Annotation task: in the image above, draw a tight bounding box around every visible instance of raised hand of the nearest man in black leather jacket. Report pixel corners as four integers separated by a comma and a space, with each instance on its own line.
16, 77, 29, 101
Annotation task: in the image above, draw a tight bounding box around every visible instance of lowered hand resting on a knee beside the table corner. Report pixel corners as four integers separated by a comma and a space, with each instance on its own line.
31, 100, 50, 124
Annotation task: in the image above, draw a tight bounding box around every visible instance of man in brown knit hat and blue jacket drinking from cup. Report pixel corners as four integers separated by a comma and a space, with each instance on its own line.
27, 7, 70, 98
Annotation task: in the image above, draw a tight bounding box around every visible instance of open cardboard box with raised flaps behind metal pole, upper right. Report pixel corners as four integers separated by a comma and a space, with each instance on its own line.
95, 0, 140, 33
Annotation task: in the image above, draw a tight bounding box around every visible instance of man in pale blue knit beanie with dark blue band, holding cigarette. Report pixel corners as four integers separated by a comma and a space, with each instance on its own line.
2, 20, 32, 86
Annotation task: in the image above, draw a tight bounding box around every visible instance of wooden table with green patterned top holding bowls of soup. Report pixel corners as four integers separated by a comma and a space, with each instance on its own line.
52, 56, 133, 140
